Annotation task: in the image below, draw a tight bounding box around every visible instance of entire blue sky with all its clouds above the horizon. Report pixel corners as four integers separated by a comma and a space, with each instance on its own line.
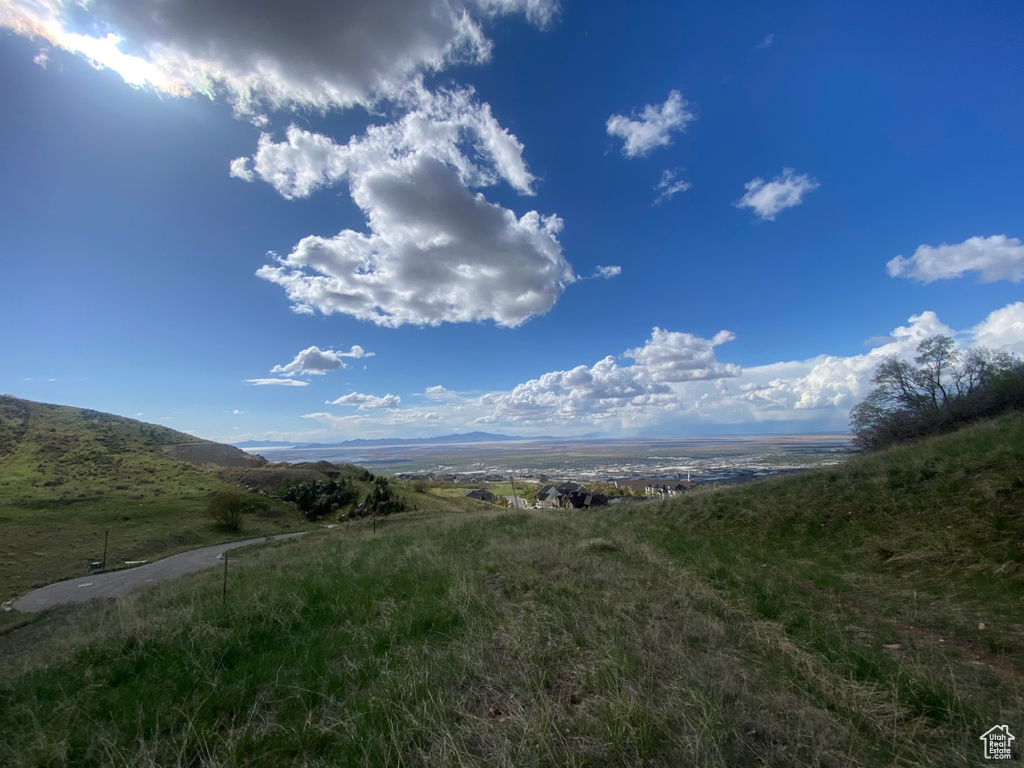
0, 0, 1024, 440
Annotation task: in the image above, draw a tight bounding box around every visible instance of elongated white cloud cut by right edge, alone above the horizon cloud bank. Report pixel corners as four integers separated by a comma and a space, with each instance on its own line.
886, 234, 1024, 283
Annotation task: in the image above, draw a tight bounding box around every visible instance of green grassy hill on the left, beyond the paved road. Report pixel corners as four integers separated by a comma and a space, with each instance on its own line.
0, 396, 302, 600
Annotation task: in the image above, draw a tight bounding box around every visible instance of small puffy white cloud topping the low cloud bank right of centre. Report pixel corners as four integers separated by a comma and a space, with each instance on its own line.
626, 328, 739, 381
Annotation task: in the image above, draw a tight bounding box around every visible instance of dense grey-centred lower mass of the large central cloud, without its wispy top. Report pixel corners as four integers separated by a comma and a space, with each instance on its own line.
257, 157, 575, 328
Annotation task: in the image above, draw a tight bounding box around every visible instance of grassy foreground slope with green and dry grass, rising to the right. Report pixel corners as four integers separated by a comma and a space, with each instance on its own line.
0, 416, 1024, 766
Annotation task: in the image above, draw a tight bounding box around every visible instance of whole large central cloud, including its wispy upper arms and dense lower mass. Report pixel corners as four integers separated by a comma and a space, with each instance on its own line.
232, 89, 577, 327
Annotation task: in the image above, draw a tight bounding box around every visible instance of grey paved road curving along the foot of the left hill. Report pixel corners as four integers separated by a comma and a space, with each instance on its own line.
10, 530, 309, 613
